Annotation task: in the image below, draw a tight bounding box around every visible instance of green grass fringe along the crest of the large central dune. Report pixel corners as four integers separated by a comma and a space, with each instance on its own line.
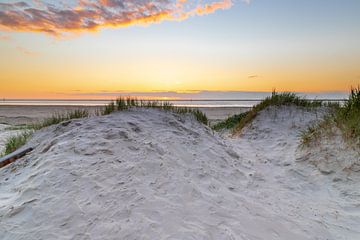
101, 97, 209, 125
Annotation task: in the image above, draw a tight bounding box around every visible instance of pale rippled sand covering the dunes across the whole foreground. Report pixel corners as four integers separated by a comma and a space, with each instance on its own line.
0, 107, 360, 240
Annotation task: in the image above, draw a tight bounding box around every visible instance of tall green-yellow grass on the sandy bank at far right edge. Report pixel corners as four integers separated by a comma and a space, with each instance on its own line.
301, 87, 360, 146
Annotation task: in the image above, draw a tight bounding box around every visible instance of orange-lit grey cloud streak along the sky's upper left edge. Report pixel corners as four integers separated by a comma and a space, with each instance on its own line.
0, 0, 239, 36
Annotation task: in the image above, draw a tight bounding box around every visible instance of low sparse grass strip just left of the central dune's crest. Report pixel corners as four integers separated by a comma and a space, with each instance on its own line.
31, 109, 90, 130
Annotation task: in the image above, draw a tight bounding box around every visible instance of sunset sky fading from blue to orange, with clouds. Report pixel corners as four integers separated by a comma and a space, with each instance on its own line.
0, 0, 360, 99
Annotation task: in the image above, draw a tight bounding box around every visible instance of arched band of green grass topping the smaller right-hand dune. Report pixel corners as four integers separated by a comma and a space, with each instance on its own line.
234, 91, 322, 133
